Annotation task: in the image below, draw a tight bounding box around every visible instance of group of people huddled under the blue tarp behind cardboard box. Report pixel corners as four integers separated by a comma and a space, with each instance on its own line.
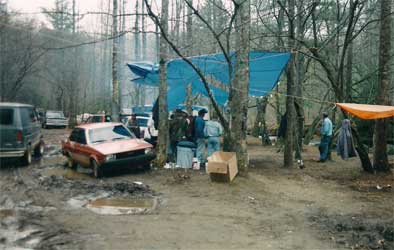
169, 109, 223, 168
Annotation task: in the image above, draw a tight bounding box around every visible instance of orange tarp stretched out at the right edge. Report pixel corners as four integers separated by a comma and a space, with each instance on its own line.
337, 103, 394, 120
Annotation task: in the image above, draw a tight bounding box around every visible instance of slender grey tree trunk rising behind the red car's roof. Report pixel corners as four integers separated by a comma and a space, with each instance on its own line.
111, 0, 119, 121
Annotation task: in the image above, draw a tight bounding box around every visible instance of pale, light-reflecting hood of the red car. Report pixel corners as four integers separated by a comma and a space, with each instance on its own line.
91, 139, 152, 155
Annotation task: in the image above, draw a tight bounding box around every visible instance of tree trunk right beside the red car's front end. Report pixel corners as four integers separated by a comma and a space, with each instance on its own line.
156, 0, 168, 167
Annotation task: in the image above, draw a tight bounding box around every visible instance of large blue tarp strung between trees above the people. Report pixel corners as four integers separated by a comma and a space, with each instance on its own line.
127, 51, 290, 110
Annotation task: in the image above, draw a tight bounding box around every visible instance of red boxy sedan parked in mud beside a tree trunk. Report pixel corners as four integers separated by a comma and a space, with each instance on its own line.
62, 122, 155, 178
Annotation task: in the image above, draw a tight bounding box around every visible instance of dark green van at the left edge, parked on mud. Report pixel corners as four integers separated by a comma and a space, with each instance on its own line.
0, 102, 44, 165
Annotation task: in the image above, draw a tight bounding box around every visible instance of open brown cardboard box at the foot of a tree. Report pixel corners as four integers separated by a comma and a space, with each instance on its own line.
207, 151, 238, 182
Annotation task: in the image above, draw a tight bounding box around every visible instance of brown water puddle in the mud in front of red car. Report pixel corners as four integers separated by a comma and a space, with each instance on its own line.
88, 198, 154, 208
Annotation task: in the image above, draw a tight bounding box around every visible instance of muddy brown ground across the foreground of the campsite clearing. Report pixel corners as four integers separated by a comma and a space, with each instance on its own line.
0, 129, 394, 250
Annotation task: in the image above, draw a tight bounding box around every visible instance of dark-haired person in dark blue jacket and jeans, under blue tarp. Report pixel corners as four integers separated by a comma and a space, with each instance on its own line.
194, 109, 208, 169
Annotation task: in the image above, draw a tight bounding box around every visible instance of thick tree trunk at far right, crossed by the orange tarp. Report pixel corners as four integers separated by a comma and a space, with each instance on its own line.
373, 0, 392, 171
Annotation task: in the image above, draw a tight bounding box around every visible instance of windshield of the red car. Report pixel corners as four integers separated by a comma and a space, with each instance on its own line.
89, 125, 135, 143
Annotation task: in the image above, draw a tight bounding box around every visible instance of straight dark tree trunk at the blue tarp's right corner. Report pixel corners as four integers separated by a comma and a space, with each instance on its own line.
284, 0, 296, 167
